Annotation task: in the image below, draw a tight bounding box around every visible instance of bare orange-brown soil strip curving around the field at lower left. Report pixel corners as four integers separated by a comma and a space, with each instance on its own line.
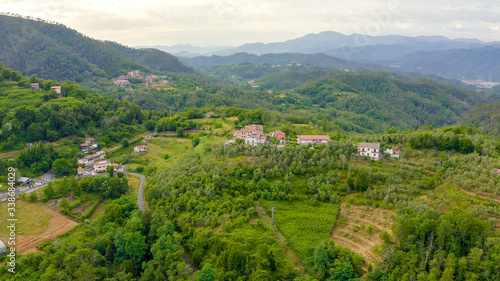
1, 203, 78, 254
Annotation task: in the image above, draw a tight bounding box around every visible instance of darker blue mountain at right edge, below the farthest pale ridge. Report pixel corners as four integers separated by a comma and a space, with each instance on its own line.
385, 46, 500, 82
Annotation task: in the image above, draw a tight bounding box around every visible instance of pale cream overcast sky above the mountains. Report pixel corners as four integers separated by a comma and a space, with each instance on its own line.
0, 0, 500, 46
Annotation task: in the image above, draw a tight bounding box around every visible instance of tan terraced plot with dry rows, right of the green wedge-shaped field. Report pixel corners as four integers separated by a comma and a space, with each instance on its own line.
330, 202, 396, 265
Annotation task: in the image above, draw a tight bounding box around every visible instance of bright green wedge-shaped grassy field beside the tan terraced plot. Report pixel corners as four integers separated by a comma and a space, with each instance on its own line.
261, 200, 340, 262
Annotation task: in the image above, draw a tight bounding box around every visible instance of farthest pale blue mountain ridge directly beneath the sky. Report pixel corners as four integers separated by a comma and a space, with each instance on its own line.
168, 31, 500, 57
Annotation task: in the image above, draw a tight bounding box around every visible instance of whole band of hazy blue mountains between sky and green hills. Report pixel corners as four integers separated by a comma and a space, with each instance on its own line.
143, 31, 500, 81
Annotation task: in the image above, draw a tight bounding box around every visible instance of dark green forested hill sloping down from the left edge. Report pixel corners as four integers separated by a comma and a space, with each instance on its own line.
0, 15, 193, 83
